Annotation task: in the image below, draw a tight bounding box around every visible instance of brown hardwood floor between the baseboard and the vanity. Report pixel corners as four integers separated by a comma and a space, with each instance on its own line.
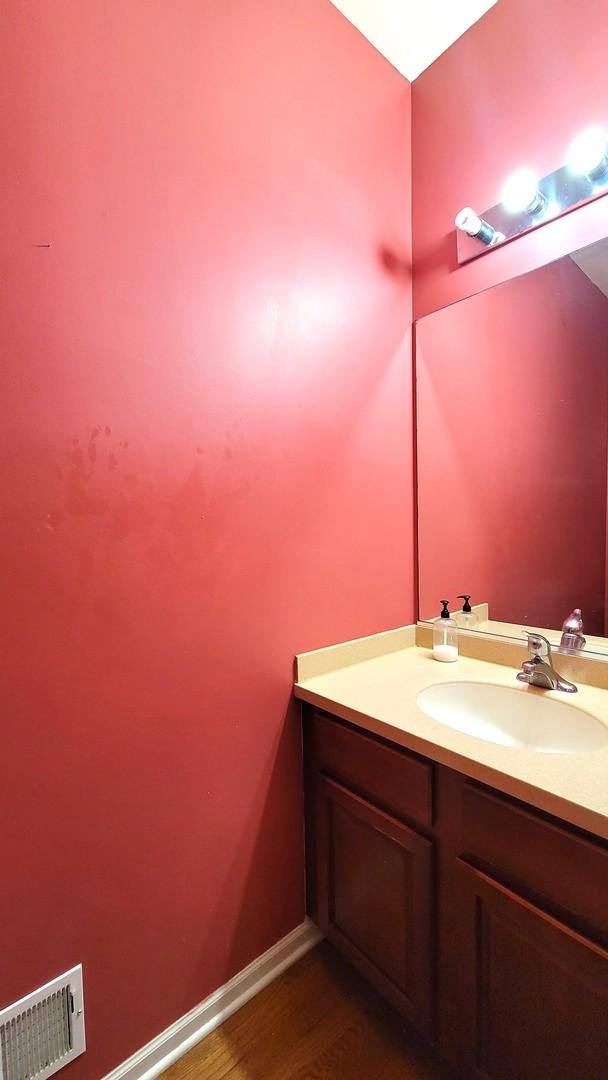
161, 942, 454, 1080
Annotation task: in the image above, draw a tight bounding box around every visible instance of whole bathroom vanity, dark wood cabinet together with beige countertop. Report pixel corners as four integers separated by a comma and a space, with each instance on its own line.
296, 635, 608, 1080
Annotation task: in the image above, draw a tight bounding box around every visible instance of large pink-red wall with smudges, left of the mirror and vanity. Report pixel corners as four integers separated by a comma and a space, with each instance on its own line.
0, 0, 414, 1080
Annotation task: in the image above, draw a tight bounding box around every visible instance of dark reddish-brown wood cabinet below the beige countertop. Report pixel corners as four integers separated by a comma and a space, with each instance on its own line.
305, 708, 608, 1080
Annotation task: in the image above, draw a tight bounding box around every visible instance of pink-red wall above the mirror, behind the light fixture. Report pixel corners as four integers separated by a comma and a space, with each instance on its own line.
411, 0, 608, 316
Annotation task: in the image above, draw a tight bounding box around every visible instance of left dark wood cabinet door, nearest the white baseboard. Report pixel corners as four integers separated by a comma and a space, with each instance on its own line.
315, 775, 433, 1034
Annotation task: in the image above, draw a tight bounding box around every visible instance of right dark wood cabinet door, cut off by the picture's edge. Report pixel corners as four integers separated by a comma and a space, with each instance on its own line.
457, 863, 608, 1080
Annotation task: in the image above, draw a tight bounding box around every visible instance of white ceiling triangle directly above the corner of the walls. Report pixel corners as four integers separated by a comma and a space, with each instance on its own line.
332, 0, 497, 82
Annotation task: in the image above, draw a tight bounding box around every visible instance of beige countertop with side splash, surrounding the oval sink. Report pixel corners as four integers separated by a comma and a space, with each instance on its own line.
295, 627, 608, 839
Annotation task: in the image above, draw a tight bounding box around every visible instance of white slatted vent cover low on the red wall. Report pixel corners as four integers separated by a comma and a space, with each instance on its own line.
0, 964, 85, 1080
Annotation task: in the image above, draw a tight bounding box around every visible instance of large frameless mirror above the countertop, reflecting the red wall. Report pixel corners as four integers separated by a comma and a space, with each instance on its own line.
416, 239, 608, 651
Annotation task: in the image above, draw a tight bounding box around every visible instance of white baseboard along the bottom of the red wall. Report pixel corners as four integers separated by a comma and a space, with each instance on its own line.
104, 919, 323, 1080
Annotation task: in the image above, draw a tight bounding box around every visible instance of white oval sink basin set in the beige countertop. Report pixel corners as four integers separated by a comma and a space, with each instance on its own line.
417, 683, 608, 754
